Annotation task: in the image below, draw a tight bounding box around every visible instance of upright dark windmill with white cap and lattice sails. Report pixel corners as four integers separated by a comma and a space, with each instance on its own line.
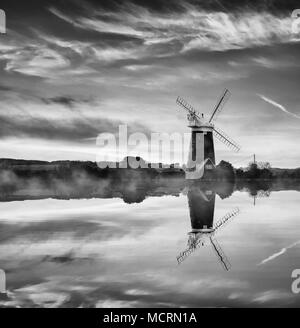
176, 89, 240, 179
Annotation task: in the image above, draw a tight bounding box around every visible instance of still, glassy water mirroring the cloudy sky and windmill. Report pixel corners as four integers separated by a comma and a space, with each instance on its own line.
0, 182, 300, 307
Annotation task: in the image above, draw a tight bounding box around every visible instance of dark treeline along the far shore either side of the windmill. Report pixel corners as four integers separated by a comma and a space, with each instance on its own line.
0, 159, 300, 181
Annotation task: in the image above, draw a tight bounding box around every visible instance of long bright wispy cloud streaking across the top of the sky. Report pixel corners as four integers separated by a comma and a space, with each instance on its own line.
49, 4, 292, 52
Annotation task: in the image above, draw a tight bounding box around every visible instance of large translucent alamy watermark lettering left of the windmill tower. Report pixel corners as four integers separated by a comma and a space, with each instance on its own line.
96, 125, 203, 169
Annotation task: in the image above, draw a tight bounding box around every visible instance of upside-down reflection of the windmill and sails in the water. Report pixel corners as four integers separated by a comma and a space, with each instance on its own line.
177, 184, 239, 271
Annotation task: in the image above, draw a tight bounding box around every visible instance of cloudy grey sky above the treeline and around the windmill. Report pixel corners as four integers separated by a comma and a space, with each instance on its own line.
0, 0, 300, 168
